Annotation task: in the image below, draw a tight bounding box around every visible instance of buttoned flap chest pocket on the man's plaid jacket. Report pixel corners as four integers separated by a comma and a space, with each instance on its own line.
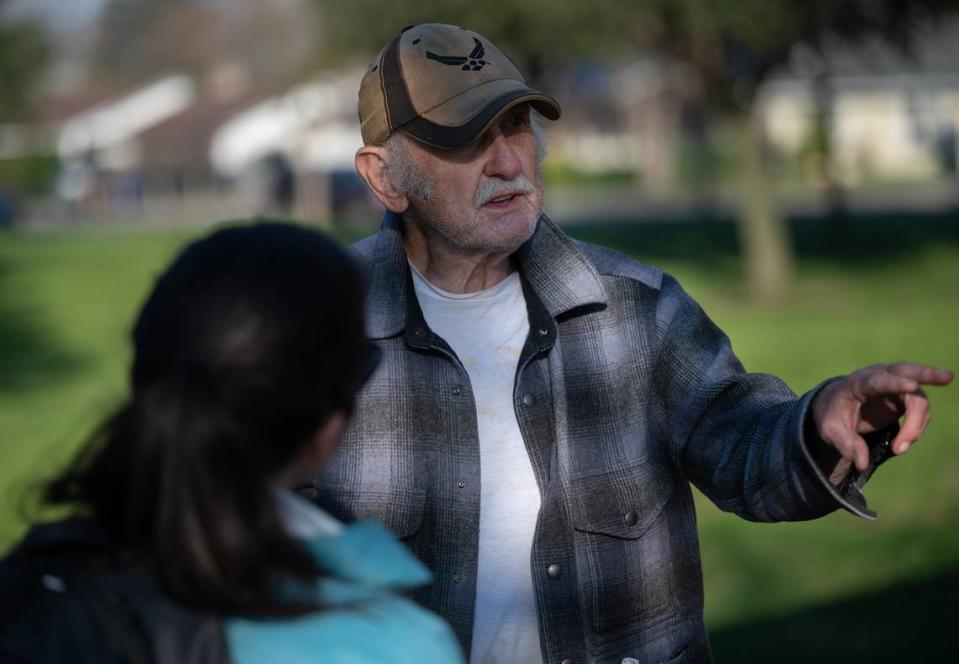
570, 461, 701, 642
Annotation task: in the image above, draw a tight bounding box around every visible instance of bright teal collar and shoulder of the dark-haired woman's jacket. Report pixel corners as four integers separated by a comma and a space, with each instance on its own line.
224, 522, 464, 664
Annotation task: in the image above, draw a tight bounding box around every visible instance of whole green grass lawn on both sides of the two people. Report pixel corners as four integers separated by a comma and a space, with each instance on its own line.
0, 218, 959, 662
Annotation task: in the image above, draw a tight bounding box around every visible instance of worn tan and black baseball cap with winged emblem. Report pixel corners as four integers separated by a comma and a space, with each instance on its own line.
358, 23, 560, 149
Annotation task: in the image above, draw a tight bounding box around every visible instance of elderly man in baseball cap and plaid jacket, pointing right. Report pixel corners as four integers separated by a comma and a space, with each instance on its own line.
308, 24, 951, 664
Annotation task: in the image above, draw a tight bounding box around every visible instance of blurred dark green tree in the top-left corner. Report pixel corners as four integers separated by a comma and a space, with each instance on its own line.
0, 0, 49, 122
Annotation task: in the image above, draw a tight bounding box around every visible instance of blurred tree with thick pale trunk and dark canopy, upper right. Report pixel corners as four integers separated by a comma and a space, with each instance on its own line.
644, 0, 959, 300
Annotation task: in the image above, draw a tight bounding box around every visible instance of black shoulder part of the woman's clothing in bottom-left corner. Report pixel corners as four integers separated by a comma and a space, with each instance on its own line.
0, 520, 231, 664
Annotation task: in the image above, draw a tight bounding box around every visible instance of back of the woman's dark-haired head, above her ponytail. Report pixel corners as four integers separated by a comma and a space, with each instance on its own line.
131, 224, 371, 473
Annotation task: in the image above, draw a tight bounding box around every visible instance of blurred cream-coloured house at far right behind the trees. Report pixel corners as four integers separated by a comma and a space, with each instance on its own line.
760, 20, 959, 186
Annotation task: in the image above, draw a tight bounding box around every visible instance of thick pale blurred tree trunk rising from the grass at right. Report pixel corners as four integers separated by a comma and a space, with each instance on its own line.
736, 104, 793, 302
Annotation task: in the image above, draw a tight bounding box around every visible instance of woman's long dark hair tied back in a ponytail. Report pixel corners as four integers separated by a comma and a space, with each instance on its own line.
44, 223, 374, 615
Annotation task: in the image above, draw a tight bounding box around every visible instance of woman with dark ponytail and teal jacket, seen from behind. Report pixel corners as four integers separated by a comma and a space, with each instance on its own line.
0, 223, 462, 664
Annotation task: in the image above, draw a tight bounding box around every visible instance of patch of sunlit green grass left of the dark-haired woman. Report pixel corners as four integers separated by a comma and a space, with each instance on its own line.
0, 230, 199, 520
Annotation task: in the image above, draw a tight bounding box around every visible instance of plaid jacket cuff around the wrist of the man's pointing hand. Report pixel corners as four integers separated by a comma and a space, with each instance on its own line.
798, 376, 899, 521
